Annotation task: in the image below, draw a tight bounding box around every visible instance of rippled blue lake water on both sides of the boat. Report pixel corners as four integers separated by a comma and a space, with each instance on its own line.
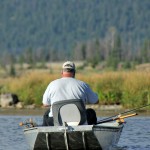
0, 116, 150, 150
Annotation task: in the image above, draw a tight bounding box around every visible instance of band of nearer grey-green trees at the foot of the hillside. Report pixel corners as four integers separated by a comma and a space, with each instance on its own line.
0, 29, 150, 75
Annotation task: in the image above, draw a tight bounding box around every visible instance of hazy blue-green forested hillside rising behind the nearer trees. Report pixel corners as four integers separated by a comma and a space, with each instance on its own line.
0, 0, 150, 54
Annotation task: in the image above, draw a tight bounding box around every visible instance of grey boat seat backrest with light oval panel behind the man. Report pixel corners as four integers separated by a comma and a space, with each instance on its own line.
52, 99, 86, 126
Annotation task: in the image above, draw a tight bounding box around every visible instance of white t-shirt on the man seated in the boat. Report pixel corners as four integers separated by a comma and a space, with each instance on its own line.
43, 77, 98, 117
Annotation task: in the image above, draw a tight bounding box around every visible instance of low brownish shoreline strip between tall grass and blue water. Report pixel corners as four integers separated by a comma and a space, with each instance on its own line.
0, 105, 150, 117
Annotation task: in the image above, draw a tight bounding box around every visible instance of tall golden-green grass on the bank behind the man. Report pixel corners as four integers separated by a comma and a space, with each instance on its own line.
0, 62, 150, 110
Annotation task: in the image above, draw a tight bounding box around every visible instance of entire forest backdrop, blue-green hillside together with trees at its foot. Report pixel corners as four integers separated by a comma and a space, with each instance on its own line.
0, 0, 150, 69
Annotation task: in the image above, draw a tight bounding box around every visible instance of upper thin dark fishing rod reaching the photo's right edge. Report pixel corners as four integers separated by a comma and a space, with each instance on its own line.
97, 104, 150, 124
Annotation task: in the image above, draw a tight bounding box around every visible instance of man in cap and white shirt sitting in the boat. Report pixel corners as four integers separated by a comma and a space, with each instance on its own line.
42, 61, 98, 126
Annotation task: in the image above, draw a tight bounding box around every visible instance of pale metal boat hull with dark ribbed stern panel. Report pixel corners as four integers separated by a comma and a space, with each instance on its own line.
24, 122, 123, 150
